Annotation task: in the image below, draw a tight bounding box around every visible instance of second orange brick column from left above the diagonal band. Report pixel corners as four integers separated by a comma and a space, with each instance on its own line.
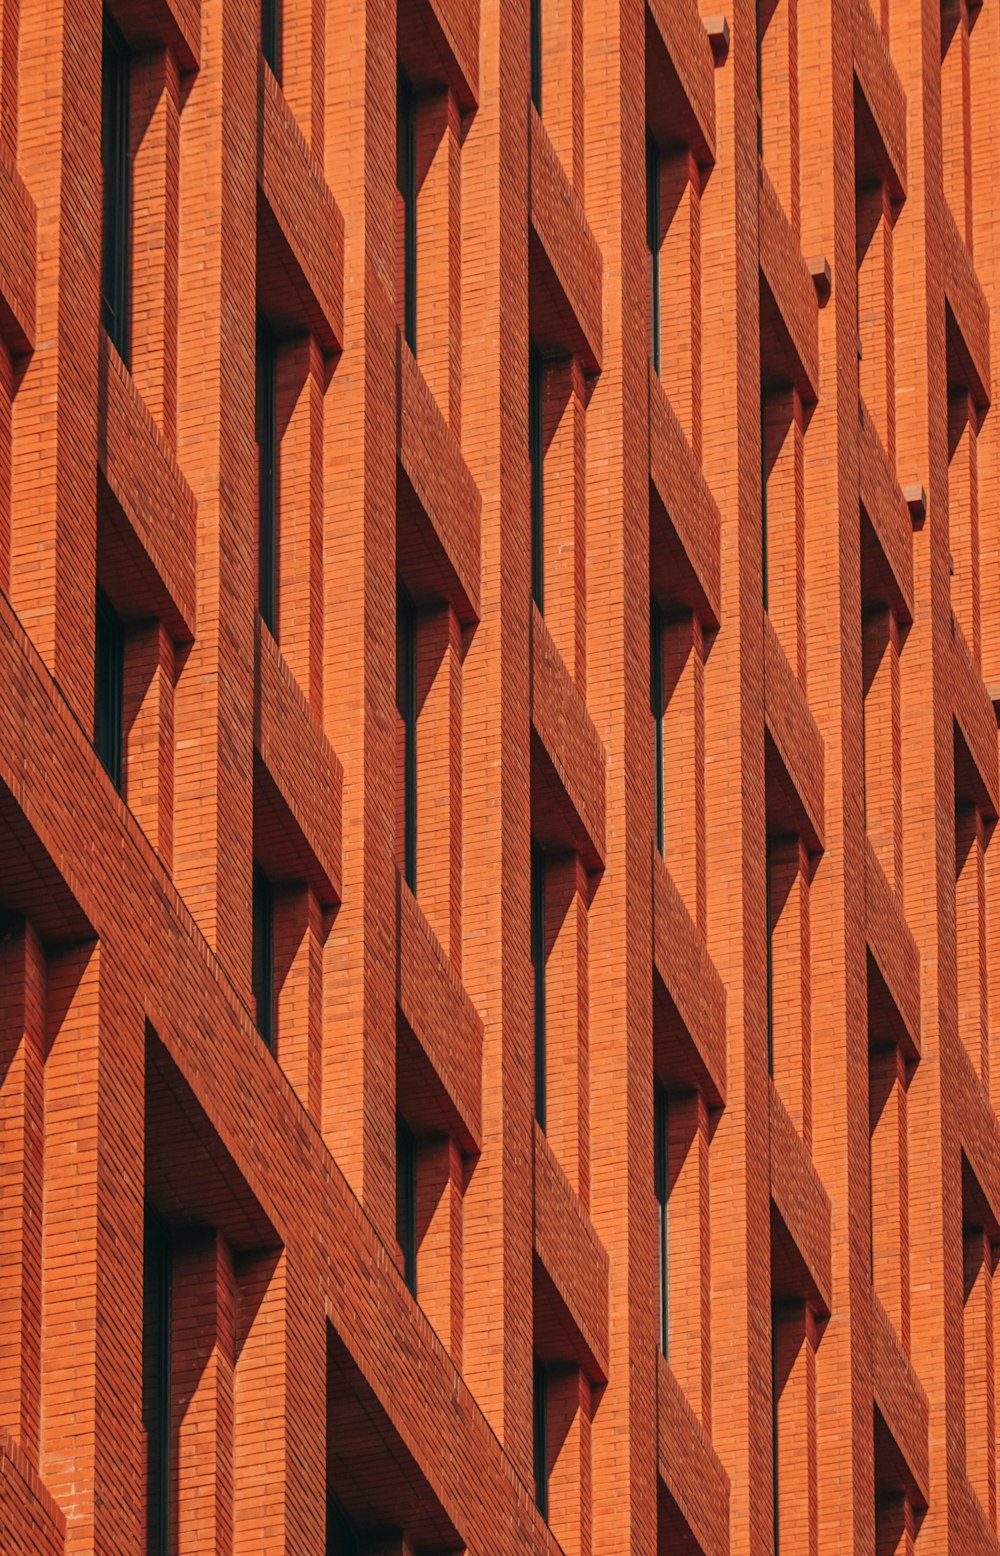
174, 0, 258, 1004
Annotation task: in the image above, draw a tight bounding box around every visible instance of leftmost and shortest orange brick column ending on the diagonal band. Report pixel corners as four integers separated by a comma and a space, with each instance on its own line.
12, 0, 101, 730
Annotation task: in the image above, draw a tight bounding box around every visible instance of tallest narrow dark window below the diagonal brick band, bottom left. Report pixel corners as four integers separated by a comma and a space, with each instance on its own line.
143, 1209, 173, 1556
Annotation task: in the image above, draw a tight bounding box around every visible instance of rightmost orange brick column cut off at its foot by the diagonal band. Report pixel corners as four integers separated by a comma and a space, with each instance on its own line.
462, 0, 533, 1486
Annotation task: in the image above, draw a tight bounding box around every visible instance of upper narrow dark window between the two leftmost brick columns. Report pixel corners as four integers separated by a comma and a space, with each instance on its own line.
101, 12, 132, 366
